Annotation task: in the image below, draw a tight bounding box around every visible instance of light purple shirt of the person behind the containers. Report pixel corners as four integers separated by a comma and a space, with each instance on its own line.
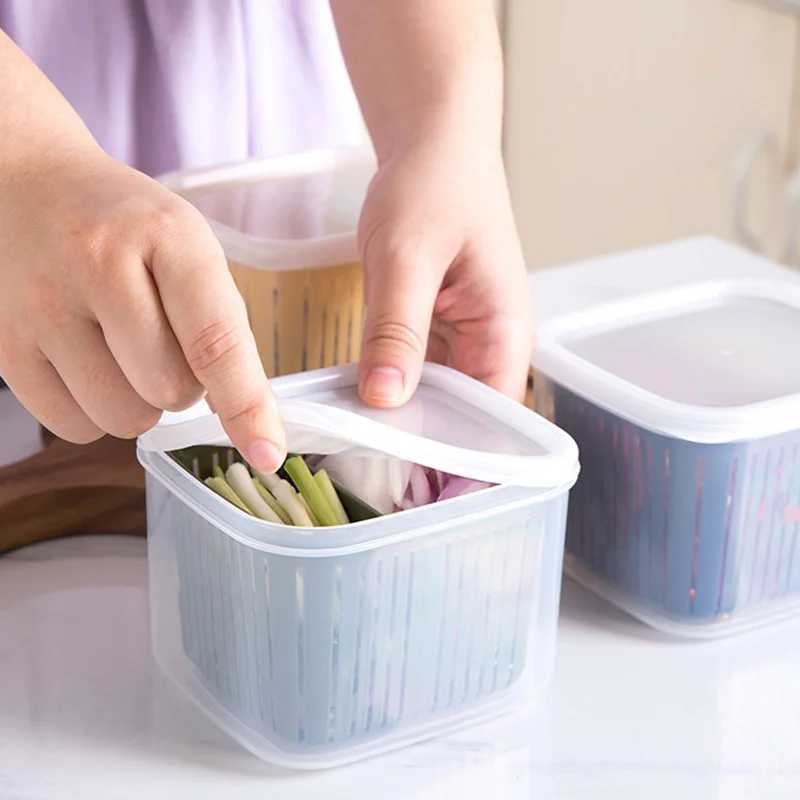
0, 0, 364, 175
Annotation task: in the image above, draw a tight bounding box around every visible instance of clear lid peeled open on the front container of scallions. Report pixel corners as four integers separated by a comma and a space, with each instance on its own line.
134, 364, 578, 489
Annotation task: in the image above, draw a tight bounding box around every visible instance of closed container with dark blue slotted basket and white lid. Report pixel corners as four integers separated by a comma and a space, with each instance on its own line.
534, 280, 800, 637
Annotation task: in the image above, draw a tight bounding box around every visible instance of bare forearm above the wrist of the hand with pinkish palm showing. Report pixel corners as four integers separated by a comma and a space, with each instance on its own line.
324, 0, 503, 160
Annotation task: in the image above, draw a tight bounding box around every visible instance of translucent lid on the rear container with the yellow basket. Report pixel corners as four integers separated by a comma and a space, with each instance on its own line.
159, 148, 376, 270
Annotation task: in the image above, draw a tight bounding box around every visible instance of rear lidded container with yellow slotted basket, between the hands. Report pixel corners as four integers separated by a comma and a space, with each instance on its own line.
160, 148, 376, 377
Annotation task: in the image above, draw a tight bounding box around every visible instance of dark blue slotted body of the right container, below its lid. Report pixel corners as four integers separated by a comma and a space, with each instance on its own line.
534, 374, 800, 624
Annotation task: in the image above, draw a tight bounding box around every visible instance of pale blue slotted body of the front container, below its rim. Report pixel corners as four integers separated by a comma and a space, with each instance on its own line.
147, 476, 567, 768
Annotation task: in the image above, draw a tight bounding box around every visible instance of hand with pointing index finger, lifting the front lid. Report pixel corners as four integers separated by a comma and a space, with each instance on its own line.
0, 151, 286, 471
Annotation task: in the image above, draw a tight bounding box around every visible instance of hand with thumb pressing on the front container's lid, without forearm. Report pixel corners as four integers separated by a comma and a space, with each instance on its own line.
359, 137, 535, 407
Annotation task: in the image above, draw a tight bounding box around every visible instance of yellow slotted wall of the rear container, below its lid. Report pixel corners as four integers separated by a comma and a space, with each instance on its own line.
229, 262, 364, 378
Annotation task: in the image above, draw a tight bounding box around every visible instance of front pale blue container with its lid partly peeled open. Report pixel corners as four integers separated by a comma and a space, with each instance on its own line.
134, 365, 578, 769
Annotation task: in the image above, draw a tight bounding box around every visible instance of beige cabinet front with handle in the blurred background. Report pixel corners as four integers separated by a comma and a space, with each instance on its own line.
503, 0, 800, 269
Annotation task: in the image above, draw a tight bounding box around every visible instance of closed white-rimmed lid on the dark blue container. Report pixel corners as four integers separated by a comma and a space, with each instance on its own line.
534, 281, 800, 443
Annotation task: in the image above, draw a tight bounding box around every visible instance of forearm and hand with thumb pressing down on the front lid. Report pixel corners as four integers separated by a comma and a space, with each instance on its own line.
331, 0, 534, 406
